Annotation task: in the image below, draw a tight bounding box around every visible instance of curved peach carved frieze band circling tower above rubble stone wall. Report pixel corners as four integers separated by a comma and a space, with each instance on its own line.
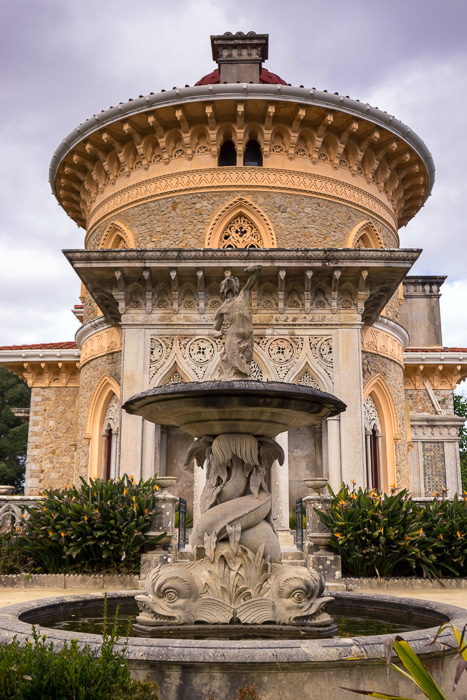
87, 167, 398, 235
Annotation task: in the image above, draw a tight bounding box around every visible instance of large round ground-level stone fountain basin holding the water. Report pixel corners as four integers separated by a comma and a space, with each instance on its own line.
0, 591, 467, 700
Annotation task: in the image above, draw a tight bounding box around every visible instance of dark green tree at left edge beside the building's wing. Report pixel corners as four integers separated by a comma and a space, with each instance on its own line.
0, 365, 31, 492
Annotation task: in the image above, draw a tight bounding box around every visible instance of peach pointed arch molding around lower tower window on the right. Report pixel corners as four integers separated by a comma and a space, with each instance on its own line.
363, 374, 400, 493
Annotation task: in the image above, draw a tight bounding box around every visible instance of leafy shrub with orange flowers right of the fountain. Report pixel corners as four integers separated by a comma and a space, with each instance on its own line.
316, 484, 450, 577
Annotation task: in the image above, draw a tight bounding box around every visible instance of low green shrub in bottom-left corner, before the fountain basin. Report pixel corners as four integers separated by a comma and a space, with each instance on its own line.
0, 604, 159, 700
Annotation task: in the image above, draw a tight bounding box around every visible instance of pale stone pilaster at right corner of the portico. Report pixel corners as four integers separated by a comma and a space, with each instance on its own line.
334, 327, 366, 486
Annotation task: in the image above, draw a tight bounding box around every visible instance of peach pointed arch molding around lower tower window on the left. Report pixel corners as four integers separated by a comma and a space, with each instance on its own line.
85, 374, 120, 479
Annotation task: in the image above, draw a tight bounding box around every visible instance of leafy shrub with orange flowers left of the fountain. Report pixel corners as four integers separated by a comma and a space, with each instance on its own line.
16, 475, 164, 573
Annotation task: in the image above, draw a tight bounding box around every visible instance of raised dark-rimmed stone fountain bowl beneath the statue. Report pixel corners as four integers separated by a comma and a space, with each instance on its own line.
123, 380, 346, 438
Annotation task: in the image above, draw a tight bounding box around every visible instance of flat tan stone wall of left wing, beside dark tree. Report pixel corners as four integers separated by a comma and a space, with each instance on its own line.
25, 387, 79, 496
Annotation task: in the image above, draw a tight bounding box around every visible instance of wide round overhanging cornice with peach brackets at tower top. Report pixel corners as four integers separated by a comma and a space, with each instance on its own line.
49, 84, 434, 226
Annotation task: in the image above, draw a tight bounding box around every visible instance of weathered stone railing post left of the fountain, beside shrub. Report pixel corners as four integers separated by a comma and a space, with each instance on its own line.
140, 476, 178, 581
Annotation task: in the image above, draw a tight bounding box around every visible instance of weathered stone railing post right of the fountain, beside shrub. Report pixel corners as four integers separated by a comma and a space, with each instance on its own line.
303, 480, 342, 585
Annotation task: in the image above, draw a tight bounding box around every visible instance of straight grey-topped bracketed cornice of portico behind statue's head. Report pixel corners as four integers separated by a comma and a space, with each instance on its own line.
65, 248, 419, 330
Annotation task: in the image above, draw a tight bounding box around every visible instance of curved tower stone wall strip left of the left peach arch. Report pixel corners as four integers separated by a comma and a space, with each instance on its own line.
76, 352, 121, 479
